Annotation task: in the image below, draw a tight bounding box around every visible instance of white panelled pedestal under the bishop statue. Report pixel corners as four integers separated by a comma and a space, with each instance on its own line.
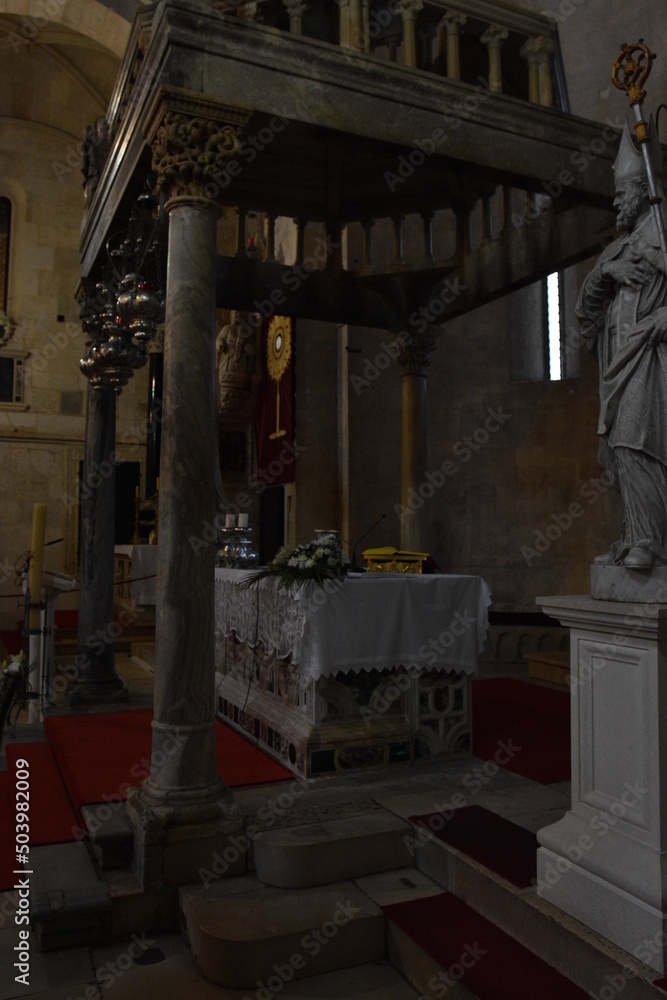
537, 597, 667, 973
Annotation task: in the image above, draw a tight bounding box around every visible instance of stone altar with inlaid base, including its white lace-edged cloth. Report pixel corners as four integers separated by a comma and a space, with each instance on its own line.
215, 569, 490, 777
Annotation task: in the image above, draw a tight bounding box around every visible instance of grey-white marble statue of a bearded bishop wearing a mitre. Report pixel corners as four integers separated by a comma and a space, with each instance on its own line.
577, 126, 667, 571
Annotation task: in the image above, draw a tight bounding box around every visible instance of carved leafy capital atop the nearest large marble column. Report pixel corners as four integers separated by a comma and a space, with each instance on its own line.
145, 88, 251, 204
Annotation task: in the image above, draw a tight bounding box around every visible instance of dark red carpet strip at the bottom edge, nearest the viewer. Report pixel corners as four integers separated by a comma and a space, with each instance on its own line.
382, 892, 588, 1000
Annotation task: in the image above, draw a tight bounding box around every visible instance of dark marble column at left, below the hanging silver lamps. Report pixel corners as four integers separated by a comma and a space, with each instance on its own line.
67, 380, 128, 707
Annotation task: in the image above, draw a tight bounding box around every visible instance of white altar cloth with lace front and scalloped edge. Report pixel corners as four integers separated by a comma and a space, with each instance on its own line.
215, 569, 491, 679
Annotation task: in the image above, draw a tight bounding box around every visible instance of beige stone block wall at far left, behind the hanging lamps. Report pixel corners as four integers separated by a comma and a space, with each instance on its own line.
0, 4, 142, 629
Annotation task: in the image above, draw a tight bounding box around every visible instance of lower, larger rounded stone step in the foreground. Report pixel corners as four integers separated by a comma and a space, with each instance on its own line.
179, 876, 385, 994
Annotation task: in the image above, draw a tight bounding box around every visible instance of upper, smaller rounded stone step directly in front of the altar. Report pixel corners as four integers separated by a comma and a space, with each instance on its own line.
253, 809, 412, 888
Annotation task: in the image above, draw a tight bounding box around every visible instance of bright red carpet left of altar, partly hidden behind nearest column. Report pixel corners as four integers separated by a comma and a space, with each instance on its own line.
44, 709, 292, 811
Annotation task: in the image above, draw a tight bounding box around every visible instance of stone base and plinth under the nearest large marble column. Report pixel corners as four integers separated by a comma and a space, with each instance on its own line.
127, 778, 247, 887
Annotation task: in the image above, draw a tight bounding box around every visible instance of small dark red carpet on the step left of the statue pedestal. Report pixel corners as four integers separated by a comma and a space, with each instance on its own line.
410, 806, 538, 889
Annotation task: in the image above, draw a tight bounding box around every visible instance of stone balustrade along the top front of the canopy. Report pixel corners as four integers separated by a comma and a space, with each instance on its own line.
212, 0, 568, 110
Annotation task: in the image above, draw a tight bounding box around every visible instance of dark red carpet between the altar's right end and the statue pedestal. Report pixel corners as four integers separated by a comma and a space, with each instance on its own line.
472, 678, 570, 785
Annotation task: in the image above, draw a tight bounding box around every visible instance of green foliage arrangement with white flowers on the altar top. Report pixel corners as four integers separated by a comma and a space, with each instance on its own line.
238, 531, 351, 591
